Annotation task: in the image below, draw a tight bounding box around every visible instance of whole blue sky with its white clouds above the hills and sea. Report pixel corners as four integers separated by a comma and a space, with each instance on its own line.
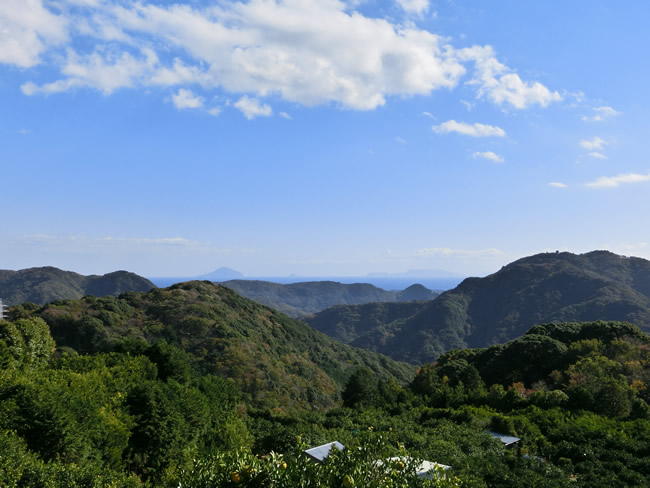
0, 0, 650, 276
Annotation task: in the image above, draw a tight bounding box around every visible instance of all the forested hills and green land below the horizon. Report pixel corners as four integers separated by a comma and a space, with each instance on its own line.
0, 251, 650, 488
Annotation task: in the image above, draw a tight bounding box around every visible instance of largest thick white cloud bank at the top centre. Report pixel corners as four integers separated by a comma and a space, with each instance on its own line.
102, 0, 464, 109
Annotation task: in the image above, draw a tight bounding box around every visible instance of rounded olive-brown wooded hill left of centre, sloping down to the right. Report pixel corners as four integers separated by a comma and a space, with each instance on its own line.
12, 281, 414, 409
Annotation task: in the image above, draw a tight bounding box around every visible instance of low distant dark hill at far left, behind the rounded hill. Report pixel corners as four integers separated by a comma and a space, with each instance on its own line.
0, 266, 156, 305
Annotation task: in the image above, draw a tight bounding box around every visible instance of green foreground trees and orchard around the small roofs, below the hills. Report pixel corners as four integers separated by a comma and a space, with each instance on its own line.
0, 318, 650, 488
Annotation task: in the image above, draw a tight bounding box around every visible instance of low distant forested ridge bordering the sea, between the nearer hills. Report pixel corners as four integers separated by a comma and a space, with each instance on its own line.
221, 280, 438, 318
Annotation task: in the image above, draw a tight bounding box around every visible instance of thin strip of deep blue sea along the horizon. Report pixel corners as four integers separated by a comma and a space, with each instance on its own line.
149, 276, 463, 291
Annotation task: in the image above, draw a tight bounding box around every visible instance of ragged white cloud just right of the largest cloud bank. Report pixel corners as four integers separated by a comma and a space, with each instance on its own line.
458, 46, 562, 109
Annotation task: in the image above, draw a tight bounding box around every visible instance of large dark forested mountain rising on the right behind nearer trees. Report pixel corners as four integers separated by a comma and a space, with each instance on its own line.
307, 251, 650, 364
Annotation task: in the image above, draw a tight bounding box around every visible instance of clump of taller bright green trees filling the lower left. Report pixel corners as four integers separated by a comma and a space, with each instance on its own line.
0, 318, 243, 486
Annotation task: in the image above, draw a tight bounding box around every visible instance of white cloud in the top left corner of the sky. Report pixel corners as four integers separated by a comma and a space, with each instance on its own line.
0, 0, 68, 68
